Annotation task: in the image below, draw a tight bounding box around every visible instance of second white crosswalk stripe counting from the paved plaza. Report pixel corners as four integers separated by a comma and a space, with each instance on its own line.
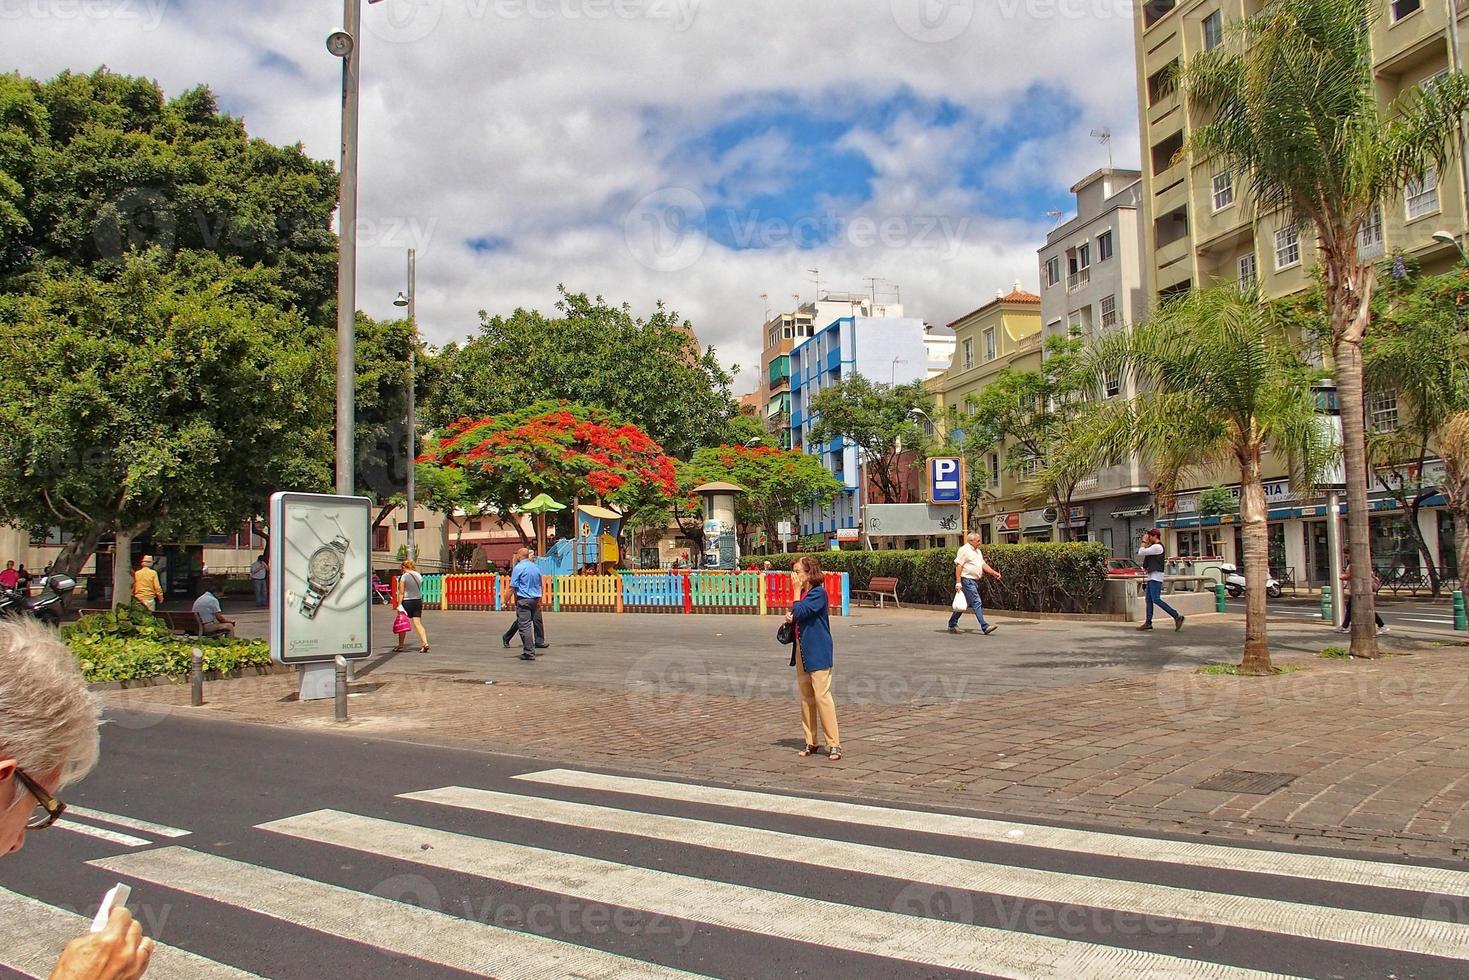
404, 786, 1469, 959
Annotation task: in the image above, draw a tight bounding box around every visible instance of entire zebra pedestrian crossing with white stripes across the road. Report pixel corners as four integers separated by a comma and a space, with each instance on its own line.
0, 768, 1469, 980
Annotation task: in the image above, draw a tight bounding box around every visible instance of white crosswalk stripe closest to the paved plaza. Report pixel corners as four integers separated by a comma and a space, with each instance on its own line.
516, 768, 1469, 898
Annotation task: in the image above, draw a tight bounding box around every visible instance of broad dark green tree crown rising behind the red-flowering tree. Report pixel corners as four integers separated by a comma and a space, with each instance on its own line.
425, 287, 737, 458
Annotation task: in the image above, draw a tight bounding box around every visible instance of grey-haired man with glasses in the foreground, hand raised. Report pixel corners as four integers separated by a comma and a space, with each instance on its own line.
0, 619, 153, 980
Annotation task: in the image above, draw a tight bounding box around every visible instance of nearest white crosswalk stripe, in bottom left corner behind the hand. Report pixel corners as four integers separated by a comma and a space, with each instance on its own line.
0, 889, 256, 980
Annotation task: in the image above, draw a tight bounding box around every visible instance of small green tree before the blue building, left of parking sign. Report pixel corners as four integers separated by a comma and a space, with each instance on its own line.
806, 375, 933, 504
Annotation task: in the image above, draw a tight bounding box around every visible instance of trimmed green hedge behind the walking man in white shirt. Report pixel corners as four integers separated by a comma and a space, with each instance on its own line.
761, 542, 1109, 613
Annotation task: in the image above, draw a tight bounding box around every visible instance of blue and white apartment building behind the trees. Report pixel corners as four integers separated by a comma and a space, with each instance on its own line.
789, 316, 928, 541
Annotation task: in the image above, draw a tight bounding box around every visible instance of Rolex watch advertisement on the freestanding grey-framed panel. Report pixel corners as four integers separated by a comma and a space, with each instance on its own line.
270, 494, 372, 664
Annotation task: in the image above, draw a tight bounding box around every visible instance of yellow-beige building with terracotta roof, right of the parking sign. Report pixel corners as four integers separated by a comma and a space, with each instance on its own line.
930, 282, 1056, 544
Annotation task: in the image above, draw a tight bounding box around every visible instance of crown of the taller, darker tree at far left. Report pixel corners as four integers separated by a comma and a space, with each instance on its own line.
0, 69, 336, 325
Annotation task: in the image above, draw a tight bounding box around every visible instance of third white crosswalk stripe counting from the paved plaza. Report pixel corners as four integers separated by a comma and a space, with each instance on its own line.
260, 810, 1271, 980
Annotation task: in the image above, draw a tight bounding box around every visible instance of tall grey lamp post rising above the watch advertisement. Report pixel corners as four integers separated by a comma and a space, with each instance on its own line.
326, 0, 382, 497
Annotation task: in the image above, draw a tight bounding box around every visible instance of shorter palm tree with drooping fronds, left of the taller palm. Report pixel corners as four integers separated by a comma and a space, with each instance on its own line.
1091, 287, 1334, 674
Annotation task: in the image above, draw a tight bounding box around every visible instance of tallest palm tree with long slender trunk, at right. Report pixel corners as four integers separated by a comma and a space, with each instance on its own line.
1183, 0, 1469, 657
